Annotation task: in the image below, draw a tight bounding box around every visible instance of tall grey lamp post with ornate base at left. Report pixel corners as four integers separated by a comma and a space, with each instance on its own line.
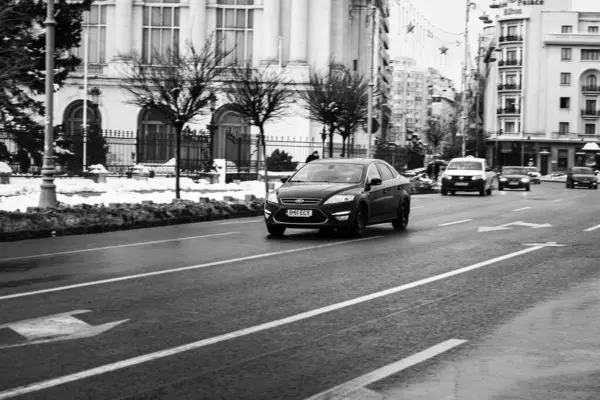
39, 0, 56, 208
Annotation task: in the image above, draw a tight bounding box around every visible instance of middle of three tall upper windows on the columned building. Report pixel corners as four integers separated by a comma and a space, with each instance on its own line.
142, 0, 179, 64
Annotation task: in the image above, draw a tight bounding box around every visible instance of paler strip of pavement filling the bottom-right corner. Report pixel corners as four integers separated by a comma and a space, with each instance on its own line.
378, 279, 600, 400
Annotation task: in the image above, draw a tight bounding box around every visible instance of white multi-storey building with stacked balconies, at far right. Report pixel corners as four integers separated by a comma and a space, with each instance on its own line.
484, 0, 600, 174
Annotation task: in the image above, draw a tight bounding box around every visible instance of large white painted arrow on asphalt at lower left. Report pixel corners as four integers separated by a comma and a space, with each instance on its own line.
0, 310, 129, 349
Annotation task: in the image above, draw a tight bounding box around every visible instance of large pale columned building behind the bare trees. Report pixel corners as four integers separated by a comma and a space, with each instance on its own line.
54, 0, 390, 164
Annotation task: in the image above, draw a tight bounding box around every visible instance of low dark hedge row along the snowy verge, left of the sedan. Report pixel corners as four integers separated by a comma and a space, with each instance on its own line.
0, 200, 264, 241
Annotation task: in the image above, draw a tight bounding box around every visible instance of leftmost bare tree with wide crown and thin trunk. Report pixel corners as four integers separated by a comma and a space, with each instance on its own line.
120, 37, 231, 199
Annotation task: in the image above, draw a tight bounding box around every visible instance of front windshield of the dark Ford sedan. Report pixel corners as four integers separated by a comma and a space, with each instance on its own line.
288, 161, 363, 183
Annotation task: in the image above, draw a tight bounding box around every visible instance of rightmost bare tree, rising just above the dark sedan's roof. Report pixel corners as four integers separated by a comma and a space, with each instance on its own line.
338, 71, 369, 155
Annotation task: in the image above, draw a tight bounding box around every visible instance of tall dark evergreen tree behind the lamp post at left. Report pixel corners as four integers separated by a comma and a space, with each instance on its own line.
0, 0, 93, 153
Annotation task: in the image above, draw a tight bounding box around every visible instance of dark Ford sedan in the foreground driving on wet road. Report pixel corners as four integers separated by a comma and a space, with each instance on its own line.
265, 158, 411, 236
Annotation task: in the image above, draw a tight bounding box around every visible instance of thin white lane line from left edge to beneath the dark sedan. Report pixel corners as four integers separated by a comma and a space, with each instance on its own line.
0, 236, 383, 301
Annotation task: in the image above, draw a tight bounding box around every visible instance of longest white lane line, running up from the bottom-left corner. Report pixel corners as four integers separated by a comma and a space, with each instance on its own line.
0, 242, 548, 400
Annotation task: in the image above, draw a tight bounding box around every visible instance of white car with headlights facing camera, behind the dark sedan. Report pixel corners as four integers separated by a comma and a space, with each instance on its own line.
441, 156, 496, 196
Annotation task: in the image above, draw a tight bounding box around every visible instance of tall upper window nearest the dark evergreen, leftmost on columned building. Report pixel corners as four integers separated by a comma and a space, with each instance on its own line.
73, 4, 106, 64
